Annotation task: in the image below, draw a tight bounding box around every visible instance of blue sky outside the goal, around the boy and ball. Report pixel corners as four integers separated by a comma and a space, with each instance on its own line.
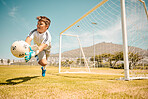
0, 0, 148, 59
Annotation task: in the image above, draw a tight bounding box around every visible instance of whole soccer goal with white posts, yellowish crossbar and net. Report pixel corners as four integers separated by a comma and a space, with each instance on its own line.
59, 0, 148, 80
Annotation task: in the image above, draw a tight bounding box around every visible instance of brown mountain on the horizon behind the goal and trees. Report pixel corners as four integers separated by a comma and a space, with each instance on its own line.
51, 42, 148, 57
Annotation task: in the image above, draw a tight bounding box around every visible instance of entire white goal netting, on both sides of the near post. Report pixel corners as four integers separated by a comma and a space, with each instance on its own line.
58, 0, 148, 77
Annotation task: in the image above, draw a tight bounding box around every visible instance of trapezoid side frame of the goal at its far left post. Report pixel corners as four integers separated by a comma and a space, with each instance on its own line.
59, 34, 90, 73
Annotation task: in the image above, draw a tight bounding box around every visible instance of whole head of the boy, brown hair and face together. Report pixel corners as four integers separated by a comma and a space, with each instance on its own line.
37, 16, 51, 33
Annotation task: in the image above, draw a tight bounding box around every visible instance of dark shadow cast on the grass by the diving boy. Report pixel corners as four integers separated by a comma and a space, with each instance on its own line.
0, 76, 39, 85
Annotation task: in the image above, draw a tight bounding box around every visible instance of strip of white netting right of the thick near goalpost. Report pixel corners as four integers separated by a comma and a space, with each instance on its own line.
126, 0, 148, 77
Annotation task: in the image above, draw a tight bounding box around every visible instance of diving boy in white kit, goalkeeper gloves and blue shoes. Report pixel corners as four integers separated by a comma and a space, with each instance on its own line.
25, 16, 51, 77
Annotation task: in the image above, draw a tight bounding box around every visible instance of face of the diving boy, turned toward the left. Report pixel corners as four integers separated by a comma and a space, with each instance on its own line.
37, 21, 48, 33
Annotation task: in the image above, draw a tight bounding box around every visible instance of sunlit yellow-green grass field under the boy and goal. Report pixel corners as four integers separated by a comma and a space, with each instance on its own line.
0, 66, 148, 99
